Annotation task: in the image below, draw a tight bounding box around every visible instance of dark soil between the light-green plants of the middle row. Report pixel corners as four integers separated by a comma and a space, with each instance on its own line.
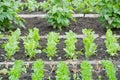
0, 38, 120, 62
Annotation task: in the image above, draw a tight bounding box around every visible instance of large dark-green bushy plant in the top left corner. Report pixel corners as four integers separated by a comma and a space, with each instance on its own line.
0, 0, 24, 31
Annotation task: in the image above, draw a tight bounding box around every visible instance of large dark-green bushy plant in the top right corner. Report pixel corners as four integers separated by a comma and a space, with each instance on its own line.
99, 0, 120, 29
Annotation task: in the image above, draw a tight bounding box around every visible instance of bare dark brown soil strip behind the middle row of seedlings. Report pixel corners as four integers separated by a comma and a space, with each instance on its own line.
18, 18, 120, 35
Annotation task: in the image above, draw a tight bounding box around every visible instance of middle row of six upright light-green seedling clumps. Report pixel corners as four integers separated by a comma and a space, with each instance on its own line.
3, 28, 120, 60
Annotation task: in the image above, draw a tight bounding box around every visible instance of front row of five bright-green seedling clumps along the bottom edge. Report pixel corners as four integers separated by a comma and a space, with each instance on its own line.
0, 60, 117, 80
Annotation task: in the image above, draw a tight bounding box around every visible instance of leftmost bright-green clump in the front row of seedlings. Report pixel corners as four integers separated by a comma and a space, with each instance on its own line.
8, 60, 26, 80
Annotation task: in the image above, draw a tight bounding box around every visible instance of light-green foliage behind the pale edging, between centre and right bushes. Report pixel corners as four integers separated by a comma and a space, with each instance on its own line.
72, 0, 100, 13
